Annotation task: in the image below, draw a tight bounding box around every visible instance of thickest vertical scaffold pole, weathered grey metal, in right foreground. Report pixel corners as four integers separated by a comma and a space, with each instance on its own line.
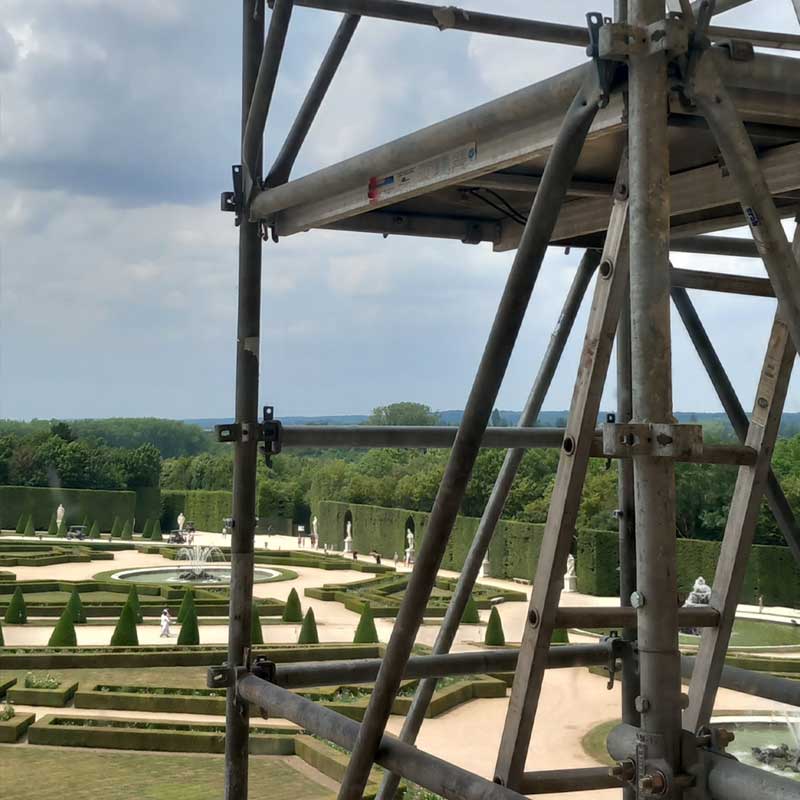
628, 0, 682, 798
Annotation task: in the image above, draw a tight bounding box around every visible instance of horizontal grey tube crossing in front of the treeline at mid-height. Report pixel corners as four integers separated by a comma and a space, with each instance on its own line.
281, 425, 755, 464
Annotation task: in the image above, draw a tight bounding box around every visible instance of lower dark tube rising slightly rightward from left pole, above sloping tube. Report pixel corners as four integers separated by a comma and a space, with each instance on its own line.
272, 642, 612, 689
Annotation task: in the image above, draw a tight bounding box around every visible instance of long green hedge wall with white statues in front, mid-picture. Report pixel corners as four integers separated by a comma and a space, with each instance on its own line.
316, 500, 544, 580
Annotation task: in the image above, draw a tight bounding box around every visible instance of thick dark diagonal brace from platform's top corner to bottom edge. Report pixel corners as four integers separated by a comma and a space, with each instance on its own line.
339, 64, 607, 800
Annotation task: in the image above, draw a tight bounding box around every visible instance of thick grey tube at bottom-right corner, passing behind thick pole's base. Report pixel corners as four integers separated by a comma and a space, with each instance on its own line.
607, 725, 800, 800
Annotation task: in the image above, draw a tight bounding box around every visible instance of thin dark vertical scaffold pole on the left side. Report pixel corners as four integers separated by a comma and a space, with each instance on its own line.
225, 0, 264, 800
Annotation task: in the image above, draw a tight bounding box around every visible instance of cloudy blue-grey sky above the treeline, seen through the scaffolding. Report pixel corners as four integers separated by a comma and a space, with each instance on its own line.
0, 0, 800, 419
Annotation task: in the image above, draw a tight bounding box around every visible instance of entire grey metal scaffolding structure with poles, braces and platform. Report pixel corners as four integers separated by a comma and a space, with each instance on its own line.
216, 0, 800, 800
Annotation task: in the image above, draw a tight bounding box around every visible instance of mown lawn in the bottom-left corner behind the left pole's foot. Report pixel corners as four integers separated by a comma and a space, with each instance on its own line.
0, 746, 333, 800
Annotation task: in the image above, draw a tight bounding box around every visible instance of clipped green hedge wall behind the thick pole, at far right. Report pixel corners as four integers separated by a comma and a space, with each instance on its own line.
576, 531, 800, 608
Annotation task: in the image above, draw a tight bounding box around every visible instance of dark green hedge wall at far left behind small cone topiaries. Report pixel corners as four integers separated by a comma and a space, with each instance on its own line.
0, 486, 135, 531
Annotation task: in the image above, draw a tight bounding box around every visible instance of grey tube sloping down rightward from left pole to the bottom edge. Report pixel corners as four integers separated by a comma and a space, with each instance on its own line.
237, 675, 524, 800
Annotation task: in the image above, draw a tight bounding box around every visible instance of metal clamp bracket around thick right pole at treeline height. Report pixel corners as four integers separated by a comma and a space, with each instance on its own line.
603, 422, 703, 459
